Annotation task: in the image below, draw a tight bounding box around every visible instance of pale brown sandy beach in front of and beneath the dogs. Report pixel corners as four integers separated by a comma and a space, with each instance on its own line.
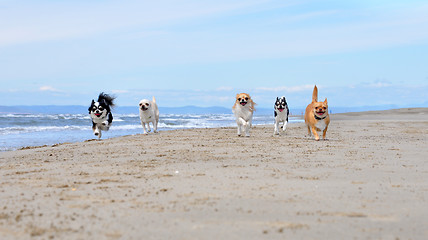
0, 109, 428, 239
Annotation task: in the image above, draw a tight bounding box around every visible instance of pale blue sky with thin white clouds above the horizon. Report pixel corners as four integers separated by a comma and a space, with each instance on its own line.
0, 0, 428, 107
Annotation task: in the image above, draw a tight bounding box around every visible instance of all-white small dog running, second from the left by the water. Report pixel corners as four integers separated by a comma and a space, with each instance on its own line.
139, 97, 159, 134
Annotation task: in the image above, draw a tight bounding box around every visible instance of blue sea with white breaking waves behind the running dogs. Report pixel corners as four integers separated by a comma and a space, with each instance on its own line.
0, 114, 303, 151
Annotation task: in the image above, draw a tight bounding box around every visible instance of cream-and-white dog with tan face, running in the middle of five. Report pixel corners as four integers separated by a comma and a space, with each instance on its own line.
232, 93, 256, 137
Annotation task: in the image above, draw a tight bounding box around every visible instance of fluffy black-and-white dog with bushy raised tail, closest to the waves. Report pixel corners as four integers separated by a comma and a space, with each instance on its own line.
88, 92, 115, 139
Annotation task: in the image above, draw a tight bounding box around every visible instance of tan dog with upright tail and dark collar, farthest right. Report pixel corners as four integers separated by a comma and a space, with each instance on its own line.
305, 85, 330, 141
